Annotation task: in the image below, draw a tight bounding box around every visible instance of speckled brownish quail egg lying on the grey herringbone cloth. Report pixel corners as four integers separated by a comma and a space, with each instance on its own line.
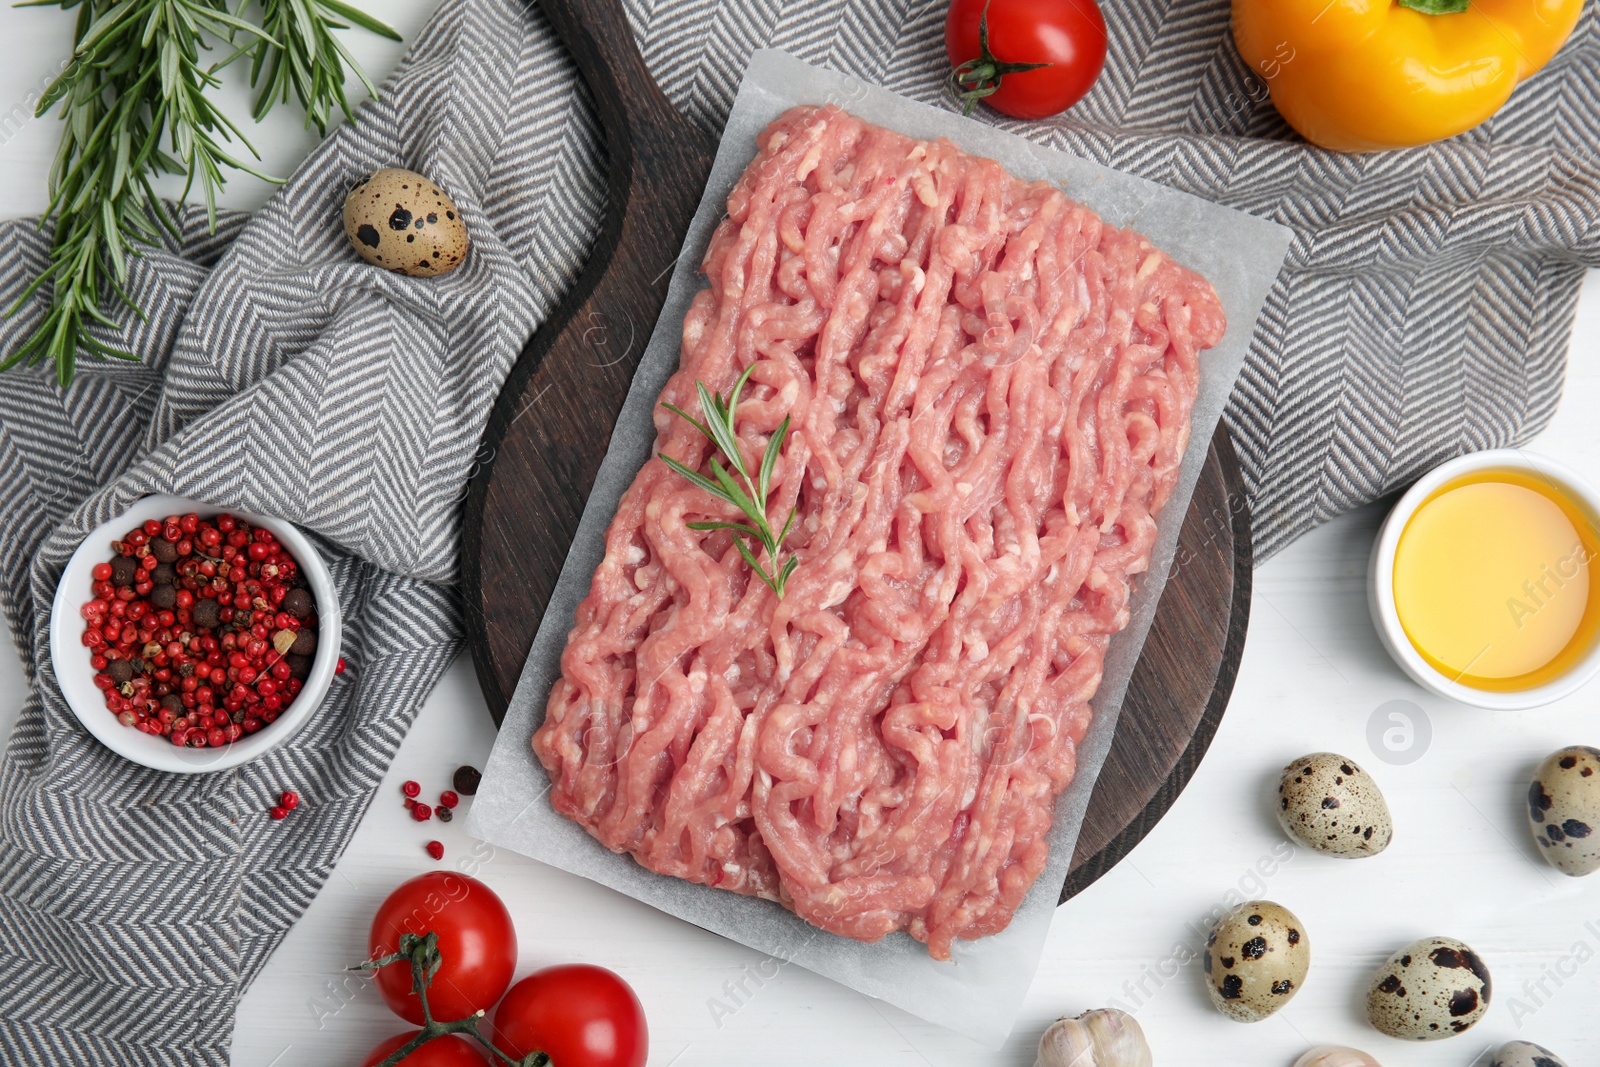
344, 166, 469, 278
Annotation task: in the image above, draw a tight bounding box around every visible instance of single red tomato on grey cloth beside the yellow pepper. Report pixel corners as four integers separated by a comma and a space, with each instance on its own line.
944, 0, 1106, 118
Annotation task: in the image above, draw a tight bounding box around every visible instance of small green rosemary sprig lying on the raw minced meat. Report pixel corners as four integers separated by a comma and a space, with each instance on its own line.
661, 365, 800, 600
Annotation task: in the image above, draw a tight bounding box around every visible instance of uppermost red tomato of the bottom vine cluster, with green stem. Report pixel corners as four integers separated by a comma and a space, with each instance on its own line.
366, 870, 517, 1025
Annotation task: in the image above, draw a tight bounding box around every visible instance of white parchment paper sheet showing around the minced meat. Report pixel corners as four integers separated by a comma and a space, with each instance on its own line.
467, 50, 1290, 1046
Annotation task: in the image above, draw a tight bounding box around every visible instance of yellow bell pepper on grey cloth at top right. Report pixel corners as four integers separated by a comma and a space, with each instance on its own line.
1234, 0, 1584, 152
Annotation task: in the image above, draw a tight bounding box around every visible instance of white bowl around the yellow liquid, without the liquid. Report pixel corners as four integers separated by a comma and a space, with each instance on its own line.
1366, 448, 1600, 712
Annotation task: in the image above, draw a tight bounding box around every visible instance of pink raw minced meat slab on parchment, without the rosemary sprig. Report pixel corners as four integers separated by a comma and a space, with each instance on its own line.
533, 107, 1224, 958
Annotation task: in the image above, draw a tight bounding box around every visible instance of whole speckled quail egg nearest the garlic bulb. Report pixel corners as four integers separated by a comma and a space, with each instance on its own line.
1202, 901, 1310, 1022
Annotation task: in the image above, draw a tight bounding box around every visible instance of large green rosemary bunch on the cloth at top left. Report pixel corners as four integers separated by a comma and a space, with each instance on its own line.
0, 0, 398, 386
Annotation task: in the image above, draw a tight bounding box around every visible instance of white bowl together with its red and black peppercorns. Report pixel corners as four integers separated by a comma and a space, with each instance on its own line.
50, 496, 341, 774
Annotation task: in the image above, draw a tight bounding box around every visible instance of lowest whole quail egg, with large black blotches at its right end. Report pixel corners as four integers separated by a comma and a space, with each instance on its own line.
1366, 937, 1491, 1041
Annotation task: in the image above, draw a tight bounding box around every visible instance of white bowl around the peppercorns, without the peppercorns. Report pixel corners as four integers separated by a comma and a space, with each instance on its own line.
50, 496, 339, 774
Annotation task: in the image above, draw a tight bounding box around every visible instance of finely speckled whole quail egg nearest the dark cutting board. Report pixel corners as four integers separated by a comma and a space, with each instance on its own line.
1278, 752, 1395, 859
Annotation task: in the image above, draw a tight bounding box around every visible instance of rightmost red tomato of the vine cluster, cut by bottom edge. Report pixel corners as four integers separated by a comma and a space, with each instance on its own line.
494, 963, 650, 1067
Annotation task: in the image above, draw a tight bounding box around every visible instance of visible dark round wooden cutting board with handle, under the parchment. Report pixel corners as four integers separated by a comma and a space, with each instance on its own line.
462, 0, 1251, 901
